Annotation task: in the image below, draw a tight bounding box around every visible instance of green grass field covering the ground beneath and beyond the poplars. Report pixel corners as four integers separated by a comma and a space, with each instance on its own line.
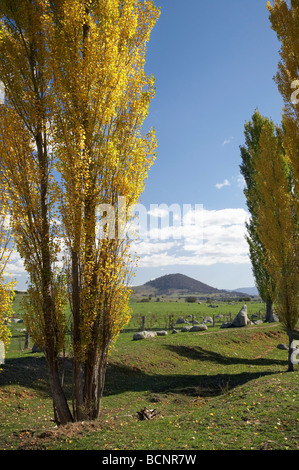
0, 299, 299, 452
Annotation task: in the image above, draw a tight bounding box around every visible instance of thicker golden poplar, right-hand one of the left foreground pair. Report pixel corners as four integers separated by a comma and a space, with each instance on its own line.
51, 0, 159, 419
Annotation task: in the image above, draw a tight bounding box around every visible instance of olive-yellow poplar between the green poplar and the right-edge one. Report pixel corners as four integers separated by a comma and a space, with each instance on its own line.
254, 121, 299, 371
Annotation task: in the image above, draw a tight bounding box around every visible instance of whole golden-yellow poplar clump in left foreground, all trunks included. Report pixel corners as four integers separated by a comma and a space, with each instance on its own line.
0, 0, 159, 424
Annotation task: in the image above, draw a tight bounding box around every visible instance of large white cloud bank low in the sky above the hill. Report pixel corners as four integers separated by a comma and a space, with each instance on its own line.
133, 208, 250, 267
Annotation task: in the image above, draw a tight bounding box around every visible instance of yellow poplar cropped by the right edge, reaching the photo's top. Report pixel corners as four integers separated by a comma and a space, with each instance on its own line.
268, 0, 299, 370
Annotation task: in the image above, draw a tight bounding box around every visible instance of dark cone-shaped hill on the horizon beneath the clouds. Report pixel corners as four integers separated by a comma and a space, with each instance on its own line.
132, 274, 245, 296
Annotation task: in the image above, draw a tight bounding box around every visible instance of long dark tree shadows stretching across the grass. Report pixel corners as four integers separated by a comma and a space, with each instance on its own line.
0, 345, 286, 398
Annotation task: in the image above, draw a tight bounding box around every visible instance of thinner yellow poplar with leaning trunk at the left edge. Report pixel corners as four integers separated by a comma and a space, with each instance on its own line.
0, 0, 71, 423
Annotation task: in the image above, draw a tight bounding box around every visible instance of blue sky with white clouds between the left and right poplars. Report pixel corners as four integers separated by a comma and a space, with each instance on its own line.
10, 0, 283, 289
